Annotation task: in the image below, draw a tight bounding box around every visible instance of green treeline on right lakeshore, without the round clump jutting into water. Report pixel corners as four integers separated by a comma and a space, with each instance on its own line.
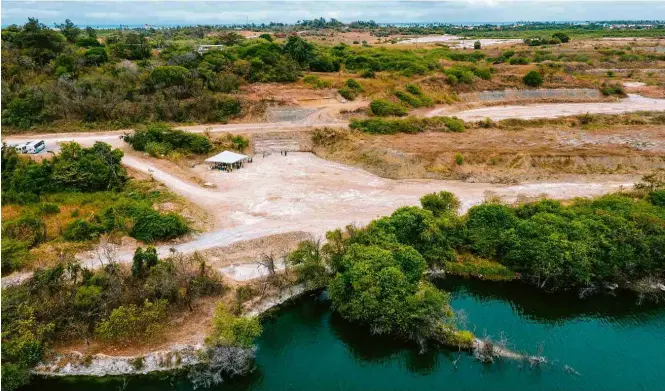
348, 190, 665, 288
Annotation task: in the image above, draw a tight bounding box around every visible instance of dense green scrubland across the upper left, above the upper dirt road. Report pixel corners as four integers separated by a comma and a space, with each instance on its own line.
2, 19, 498, 129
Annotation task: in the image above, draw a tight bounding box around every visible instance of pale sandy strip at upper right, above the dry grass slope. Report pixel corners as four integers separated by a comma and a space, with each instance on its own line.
426, 94, 665, 121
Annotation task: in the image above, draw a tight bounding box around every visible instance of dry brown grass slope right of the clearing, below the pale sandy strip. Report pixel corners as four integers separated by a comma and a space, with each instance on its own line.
314, 114, 665, 183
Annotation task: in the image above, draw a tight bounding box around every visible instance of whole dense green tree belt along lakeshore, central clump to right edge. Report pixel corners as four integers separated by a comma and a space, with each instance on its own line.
288, 186, 665, 347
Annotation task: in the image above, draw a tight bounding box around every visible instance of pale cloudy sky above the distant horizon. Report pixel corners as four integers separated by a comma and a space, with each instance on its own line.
1, 0, 665, 26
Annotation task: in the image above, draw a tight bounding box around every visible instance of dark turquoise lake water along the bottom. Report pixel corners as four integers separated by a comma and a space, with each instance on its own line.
23, 280, 665, 391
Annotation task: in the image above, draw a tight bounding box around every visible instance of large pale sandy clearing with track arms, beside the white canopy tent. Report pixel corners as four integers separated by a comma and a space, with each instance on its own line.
81, 153, 631, 272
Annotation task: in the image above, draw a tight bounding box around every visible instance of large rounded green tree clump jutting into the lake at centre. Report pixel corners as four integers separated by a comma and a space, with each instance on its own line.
329, 244, 452, 343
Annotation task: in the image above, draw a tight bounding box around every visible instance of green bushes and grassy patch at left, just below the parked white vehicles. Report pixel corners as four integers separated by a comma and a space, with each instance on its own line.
2, 142, 190, 273
